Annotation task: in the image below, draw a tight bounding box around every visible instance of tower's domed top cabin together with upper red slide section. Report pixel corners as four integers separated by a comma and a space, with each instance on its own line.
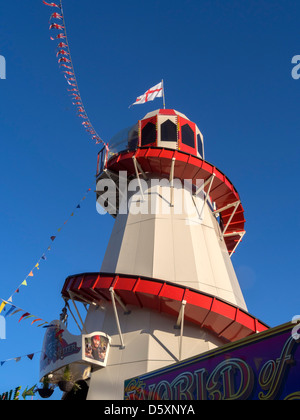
96, 109, 246, 256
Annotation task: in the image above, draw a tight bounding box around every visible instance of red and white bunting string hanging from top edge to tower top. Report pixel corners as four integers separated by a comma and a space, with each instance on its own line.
43, 0, 108, 148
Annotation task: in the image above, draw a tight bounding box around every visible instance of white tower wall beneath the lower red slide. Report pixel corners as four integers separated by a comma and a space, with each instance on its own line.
85, 305, 226, 400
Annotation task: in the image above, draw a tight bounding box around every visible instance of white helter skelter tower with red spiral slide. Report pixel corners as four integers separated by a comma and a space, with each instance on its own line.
62, 109, 267, 399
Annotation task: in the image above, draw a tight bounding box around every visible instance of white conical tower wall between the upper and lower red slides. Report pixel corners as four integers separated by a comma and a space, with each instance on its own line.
101, 178, 246, 309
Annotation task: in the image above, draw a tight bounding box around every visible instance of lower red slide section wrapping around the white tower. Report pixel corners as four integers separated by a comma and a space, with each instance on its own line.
62, 273, 269, 341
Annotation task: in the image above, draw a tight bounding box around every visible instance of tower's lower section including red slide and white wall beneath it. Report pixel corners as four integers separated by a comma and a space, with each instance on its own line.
62, 273, 268, 400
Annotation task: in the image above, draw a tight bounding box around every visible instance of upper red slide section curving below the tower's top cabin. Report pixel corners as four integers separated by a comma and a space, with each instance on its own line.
97, 147, 245, 255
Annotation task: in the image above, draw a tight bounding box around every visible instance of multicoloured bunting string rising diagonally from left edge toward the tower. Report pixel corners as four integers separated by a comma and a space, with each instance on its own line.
0, 188, 91, 314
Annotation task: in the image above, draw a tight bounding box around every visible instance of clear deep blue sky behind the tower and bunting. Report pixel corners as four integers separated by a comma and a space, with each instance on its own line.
0, 0, 300, 398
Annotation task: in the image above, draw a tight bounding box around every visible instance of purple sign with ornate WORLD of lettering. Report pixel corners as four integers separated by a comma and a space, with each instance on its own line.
124, 323, 300, 401
